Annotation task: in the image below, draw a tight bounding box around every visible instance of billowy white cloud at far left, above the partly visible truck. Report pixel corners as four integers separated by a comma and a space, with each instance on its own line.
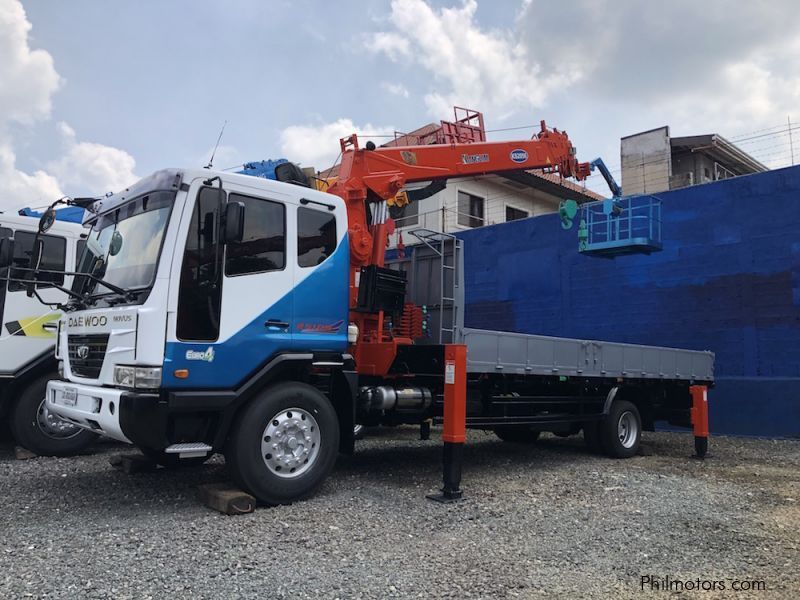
0, 0, 136, 210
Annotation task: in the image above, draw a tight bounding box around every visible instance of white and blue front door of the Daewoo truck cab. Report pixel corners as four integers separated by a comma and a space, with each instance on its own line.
165, 186, 295, 389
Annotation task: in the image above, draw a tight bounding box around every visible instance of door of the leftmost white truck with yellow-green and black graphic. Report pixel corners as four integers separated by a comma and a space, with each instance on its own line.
0, 229, 67, 374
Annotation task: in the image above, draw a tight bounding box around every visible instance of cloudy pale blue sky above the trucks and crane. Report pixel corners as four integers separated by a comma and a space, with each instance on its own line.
0, 0, 800, 210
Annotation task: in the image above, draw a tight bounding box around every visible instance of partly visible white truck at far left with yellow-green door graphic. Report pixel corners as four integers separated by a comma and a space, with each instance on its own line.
0, 213, 97, 456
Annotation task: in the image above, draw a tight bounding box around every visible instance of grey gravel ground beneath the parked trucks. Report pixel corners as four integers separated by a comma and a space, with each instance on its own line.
0, 428, 800, 598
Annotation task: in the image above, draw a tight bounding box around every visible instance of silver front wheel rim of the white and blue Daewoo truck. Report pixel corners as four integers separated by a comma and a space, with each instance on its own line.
261, 408, 322, 479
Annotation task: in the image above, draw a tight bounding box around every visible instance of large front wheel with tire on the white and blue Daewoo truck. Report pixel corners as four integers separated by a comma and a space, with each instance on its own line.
225, 382, 339, 506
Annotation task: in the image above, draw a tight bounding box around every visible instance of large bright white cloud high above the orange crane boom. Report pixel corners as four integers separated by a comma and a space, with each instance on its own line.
365, 0, 582, 119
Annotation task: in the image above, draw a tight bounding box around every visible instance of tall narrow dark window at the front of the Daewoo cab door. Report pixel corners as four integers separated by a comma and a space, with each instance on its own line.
177, 187, 222, 341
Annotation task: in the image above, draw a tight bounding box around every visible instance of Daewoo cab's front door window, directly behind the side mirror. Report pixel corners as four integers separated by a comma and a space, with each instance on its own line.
225, 194, 286, 276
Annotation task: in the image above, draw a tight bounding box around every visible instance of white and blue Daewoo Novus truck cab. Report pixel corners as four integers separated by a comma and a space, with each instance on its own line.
47, 170, 353, 502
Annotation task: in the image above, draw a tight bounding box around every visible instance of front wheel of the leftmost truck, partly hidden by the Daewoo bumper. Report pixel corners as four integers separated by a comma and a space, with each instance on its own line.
10, 373, 98, 456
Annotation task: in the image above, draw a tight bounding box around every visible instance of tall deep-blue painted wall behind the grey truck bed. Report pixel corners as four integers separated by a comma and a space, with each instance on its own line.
459, 167, 800, 437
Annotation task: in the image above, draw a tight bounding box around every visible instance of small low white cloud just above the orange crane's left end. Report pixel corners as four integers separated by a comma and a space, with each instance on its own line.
280, 118, 394, 171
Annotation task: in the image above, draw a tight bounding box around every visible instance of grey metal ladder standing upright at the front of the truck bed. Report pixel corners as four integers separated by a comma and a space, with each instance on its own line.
409, 228, 462, 344
